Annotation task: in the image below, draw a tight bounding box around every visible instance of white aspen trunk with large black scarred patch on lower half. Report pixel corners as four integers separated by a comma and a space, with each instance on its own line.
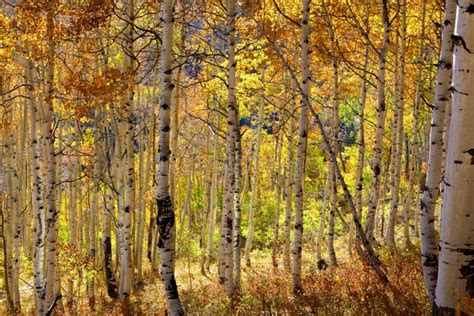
156, 0, 184, 315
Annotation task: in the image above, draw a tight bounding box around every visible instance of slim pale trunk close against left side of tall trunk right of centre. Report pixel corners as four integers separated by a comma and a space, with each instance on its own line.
283, 102, 296, 272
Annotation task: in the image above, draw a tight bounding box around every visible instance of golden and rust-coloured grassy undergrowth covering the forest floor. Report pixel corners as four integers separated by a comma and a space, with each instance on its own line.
0, 242, 430, 315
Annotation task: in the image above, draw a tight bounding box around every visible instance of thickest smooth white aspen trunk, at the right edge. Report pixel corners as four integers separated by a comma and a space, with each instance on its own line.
435, 0, 474, 315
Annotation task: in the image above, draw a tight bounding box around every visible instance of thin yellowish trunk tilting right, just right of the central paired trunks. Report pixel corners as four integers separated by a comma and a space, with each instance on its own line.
245, 74, 265, 267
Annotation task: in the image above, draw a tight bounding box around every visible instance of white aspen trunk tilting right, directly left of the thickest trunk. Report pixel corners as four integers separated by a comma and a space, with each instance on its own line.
417, 0, 456, 303
